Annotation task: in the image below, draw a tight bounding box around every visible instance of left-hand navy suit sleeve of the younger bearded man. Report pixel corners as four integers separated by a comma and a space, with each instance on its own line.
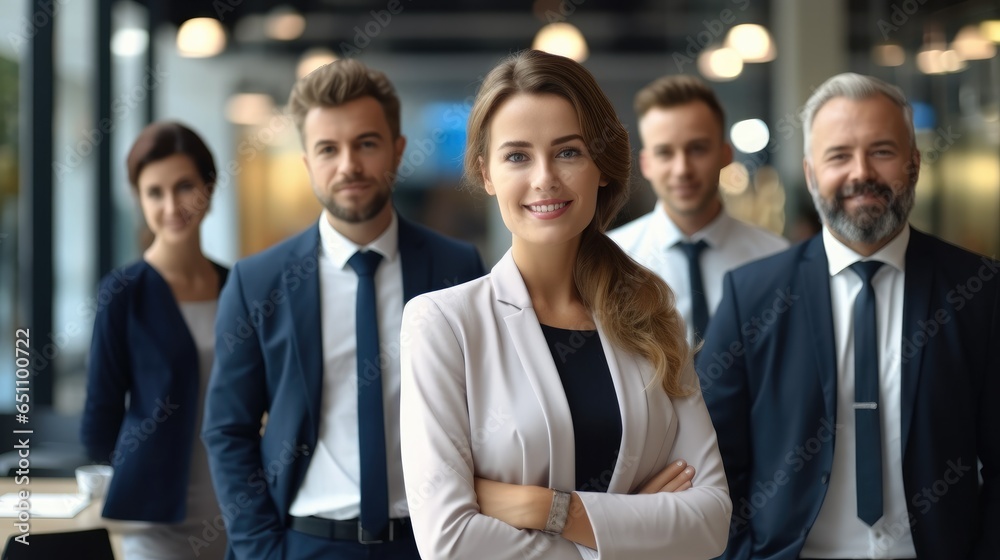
202, 264, 285, 559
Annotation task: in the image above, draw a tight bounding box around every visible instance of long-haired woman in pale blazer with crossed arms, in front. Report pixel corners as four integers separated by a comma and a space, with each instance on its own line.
401, 51, 732, 560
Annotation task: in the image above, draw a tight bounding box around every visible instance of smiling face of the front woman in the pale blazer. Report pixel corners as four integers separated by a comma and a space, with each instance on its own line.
482, 94, 607, 252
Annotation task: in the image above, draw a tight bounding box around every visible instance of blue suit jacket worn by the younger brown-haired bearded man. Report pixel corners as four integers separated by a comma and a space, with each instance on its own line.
202, 217, 485, 558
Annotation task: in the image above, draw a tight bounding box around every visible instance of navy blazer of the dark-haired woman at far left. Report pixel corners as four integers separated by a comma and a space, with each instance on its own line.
80, 260, 228, 523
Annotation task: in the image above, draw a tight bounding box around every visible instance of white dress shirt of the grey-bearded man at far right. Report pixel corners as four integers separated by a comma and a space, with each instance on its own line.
800, 225, 917, 558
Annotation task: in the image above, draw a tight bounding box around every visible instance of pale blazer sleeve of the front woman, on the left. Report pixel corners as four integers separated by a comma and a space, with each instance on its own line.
400, 296, 580, 560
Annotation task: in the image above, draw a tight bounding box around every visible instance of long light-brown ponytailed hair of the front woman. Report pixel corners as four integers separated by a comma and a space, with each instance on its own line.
465, 50, 691, 396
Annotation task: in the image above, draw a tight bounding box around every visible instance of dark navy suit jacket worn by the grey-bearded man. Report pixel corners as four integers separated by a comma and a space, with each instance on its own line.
697, 228, 1000, 560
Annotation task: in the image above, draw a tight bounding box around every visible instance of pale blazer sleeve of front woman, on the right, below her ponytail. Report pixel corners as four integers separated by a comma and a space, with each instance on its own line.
577, 360, 732, 560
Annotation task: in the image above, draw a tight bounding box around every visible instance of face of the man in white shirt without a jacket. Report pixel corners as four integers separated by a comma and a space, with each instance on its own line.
639, 101, 733, 222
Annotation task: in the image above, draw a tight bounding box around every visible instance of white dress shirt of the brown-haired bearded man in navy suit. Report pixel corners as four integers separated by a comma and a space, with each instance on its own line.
289, 211, 409, 519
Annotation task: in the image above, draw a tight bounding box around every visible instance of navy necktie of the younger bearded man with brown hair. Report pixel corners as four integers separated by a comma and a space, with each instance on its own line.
347, 251, 389, 539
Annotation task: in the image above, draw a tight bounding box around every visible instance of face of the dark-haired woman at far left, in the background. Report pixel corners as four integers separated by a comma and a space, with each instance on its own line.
136, 154, 211, 243
